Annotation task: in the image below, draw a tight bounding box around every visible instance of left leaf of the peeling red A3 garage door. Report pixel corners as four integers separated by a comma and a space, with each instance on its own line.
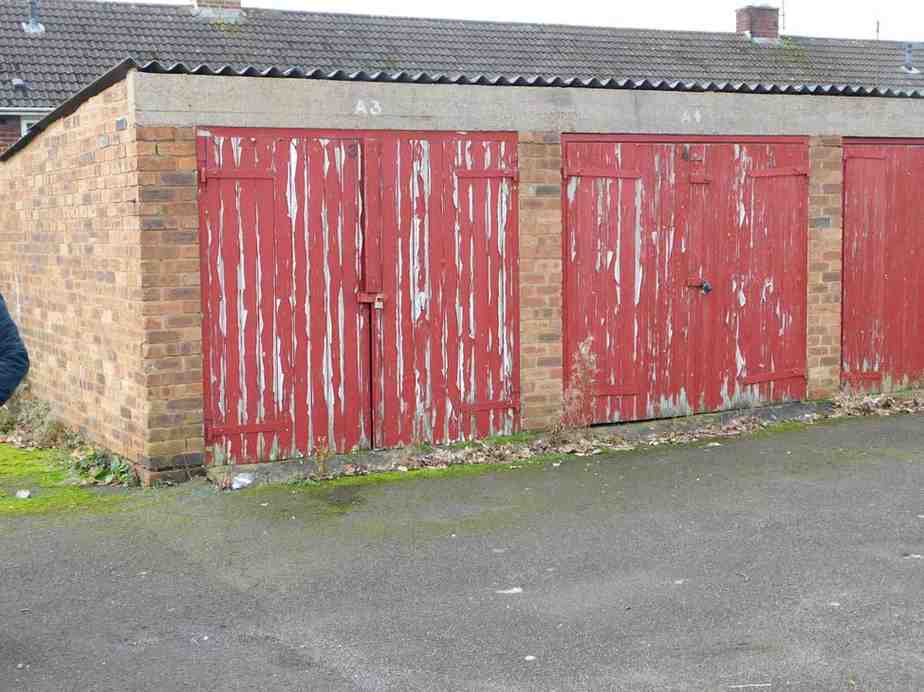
201, 133, 372, 461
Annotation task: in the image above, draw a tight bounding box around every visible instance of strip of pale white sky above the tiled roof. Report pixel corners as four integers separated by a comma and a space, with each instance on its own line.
113, 0, 924, 42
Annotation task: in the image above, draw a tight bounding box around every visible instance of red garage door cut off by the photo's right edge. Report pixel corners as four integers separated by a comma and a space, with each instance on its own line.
842, 140, 924, 391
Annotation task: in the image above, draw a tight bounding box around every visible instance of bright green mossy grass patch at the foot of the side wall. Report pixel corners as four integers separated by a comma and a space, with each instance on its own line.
0, 445, 125, 517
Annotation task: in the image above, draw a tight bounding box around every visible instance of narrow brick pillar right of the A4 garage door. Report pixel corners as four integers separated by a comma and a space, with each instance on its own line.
807, 137, 844, 399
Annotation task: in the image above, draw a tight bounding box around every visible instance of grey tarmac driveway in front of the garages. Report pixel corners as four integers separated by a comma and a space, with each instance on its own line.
0, 416, 924, 691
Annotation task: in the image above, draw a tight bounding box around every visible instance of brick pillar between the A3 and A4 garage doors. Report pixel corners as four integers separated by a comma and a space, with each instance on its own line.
519, 132, 562, 429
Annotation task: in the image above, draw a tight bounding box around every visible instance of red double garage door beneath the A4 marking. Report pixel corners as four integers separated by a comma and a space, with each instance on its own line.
563, 136, 808, 422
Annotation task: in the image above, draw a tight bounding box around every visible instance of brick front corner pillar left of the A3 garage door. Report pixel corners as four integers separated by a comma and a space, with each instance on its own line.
137, 127, 204, 477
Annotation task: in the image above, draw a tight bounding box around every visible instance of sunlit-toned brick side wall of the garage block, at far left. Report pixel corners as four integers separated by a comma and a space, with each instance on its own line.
0, 83, 145, 458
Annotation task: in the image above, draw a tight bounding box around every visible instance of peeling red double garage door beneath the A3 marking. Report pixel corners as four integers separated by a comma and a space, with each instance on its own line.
199, 129, 519, 461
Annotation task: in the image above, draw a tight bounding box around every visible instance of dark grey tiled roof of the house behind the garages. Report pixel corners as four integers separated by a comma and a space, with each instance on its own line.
0, 0, 924, 108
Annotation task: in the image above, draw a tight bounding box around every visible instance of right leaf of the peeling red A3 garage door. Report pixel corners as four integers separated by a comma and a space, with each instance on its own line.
381, 135, 519, 447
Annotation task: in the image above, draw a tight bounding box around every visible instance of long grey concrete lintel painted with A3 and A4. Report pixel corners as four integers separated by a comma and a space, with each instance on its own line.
136, 73, 924, 137
